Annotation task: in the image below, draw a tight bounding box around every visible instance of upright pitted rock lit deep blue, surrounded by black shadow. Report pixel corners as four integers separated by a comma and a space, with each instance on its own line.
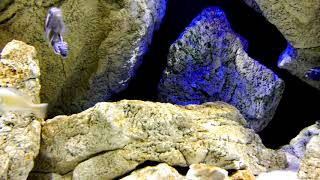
159, 8, 284, 131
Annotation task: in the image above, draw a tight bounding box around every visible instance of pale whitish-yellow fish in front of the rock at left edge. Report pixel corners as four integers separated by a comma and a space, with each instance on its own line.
0, 87, 48, 118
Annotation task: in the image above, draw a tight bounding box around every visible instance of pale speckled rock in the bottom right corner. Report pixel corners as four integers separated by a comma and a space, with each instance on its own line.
298, 135, 320, 179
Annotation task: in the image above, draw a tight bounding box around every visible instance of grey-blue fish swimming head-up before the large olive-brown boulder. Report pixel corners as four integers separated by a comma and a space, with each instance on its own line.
45, 7, 68, 58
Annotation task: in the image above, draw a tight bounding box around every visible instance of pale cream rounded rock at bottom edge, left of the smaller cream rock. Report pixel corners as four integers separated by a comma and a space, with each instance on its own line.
121, 163, 184, 180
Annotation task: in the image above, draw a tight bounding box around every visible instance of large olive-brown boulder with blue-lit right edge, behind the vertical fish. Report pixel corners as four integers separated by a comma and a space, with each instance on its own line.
0, 0, 166, 114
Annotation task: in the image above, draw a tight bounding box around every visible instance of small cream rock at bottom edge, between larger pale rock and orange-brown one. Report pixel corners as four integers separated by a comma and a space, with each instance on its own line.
186, 164, 228, 180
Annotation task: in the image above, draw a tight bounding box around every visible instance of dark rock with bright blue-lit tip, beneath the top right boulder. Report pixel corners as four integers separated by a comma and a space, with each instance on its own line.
278, 44, 320, 90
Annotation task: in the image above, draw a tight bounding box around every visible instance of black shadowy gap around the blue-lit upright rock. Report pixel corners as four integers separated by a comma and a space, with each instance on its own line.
110, 0, 320, 148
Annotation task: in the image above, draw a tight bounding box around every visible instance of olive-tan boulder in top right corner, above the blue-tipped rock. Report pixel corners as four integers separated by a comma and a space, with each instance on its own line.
244, 0, 320, 48
